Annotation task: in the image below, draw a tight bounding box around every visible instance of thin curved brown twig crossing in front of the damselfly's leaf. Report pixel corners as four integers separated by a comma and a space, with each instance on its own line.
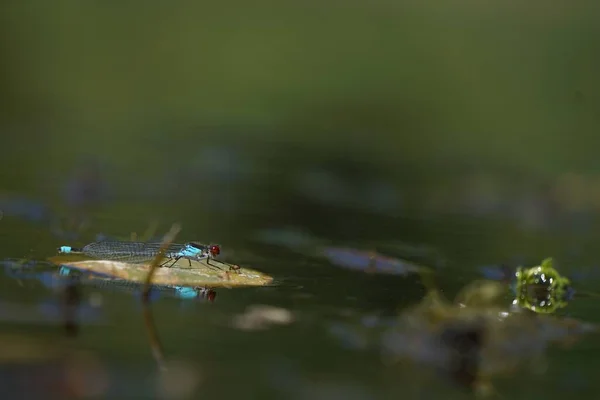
142, 224, 181, 370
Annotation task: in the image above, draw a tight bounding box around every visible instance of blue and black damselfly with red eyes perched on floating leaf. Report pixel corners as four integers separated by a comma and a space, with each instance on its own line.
58, 240, 238, 270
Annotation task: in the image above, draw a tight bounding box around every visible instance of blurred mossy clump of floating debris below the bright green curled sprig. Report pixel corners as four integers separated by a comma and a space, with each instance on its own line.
381, 282, 597, 391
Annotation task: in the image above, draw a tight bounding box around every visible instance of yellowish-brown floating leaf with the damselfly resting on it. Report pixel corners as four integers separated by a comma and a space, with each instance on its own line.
48, 256, 273, 287
